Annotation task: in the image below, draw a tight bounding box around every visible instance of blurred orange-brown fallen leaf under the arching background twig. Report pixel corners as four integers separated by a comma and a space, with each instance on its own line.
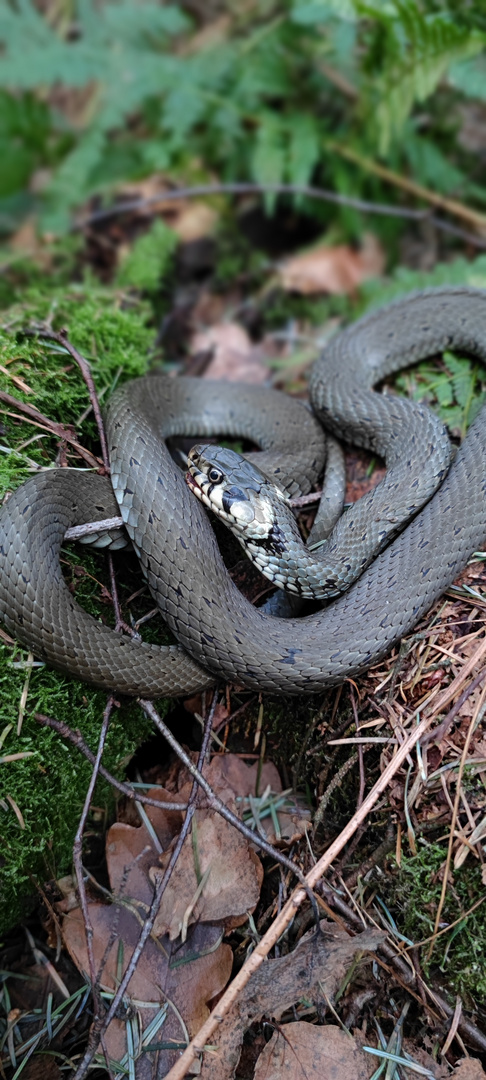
279, 233, 384, 296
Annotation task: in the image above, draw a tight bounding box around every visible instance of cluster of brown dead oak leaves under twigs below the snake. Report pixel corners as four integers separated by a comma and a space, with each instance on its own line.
60, 755, 306, 1080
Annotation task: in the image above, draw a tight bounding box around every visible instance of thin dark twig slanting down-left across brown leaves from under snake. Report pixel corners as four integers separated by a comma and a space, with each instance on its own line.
72, 693, 217, 1080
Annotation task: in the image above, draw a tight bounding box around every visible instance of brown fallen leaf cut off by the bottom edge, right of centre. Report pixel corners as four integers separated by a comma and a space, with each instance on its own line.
255, 1021, 376, 1080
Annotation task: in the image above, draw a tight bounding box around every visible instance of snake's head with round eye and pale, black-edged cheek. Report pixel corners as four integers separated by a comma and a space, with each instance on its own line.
186, 445, 288, 544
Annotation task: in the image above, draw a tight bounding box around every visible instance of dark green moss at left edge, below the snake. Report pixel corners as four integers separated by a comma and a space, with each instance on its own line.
0, 647, 156, 929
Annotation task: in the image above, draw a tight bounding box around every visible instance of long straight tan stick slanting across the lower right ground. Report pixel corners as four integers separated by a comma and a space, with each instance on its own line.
166, 639, 486, 1080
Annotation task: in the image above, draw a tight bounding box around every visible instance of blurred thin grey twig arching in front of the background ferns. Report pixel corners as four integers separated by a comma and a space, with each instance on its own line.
72, 182, 486, 247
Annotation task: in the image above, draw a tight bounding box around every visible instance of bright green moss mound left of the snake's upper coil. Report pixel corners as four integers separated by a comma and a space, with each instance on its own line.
0, 285, 152, 496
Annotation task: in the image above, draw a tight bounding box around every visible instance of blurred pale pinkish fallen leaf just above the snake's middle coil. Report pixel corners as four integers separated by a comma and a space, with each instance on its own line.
190, 323, 268, 383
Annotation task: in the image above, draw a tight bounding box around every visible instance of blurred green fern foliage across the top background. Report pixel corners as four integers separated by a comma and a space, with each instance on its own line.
0, 0, 486, 232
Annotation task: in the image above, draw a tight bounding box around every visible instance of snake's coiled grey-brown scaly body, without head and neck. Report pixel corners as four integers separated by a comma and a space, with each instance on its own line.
0, 287, 486, 697
